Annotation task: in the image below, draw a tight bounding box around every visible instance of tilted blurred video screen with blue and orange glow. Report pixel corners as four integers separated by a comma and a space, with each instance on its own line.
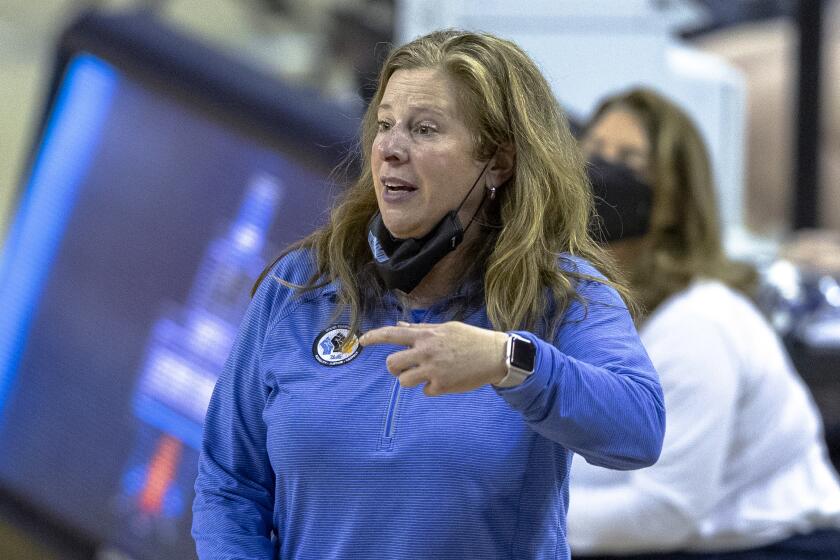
0, 54, 350, 560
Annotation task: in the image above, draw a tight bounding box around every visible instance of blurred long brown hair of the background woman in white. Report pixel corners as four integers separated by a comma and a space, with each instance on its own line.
584, 88, 757, 311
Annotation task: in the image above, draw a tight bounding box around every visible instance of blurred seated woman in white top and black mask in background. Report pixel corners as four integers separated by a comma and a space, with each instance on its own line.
568, 89, 840, 560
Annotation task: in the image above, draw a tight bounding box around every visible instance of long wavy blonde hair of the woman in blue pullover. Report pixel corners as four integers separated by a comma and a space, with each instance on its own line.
258, 30, 635, 333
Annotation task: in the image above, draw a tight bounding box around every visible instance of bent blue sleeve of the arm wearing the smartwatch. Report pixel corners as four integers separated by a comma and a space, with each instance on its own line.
497, 269, 665, 470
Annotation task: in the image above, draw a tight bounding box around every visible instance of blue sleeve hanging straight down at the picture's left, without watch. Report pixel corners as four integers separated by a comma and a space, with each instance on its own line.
192, 266, 284, 560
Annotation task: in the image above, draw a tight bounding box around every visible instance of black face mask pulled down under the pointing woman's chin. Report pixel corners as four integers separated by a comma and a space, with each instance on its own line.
368, 161, 490, 293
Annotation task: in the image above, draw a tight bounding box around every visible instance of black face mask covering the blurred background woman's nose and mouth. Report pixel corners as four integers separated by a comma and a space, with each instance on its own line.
587, 156, 653, 243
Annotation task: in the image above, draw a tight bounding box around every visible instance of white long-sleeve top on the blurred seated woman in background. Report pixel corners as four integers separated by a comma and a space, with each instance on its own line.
568, 281, 840, 554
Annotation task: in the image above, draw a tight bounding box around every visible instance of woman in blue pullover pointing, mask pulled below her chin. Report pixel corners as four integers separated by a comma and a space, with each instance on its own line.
193, 31, 664, 559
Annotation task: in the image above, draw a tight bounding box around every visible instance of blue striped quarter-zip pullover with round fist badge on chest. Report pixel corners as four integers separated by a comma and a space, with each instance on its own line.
193, 251, 664, 560
